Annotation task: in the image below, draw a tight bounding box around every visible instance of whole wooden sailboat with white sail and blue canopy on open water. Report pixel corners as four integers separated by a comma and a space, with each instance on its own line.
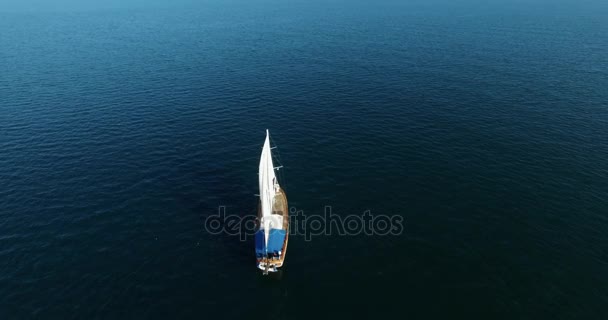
255, 130, 289, 274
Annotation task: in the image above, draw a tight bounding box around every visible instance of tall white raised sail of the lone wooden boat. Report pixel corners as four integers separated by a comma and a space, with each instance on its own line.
259, 130, 278, 245
